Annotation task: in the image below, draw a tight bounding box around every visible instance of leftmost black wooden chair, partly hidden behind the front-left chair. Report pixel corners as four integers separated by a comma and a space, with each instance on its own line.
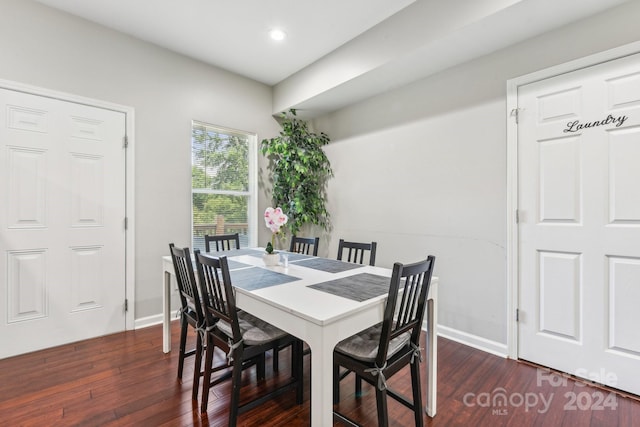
169, 243, 205, 379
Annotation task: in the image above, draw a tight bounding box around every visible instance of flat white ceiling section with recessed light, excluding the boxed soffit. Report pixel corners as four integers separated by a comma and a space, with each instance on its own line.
37, 0, 415, 85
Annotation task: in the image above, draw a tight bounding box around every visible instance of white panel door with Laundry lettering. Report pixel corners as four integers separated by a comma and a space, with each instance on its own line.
518, 51, 640, 394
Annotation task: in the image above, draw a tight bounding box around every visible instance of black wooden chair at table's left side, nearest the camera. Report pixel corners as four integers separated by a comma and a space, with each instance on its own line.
194, 251, 303, 426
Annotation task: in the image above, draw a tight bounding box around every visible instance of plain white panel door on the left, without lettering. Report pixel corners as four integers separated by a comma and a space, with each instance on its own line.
0, 89, 125, 358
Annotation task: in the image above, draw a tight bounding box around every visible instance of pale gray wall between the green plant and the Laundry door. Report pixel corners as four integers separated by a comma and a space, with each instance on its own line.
313, 2, 640, 354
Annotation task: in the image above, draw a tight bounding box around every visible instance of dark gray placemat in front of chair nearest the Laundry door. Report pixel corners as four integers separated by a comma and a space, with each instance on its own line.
309, 273, 391, 302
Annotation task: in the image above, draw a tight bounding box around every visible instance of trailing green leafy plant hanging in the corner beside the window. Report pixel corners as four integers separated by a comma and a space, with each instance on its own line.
261, 109, 333, 234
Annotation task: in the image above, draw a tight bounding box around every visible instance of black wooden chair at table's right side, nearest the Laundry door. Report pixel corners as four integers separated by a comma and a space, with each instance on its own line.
333, 256, 435, 426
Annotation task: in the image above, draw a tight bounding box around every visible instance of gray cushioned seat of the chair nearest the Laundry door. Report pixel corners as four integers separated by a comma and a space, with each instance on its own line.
336, 323, 411, 362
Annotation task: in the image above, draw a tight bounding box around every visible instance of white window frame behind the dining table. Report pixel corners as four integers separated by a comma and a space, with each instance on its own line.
189, 120, 258, 247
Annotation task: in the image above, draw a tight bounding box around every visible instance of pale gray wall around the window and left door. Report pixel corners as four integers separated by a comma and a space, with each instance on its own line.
0, 0, 279, 319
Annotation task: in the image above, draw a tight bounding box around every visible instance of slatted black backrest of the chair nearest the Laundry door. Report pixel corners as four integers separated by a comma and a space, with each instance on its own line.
376, 255, 436, 366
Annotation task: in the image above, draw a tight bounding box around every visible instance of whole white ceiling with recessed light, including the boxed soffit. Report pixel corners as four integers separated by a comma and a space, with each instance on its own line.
36, 0, 636, 116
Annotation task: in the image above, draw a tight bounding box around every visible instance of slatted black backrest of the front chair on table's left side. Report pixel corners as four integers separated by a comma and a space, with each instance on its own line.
194, 250, 242, 342
